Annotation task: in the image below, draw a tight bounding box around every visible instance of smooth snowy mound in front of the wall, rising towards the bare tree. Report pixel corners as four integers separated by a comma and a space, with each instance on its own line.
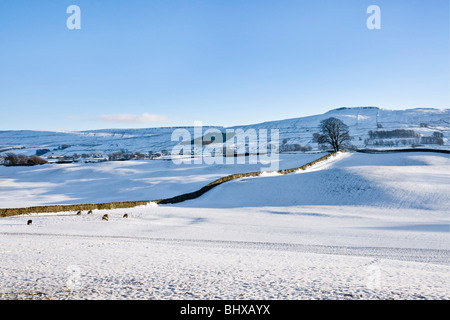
182, 152, 450, 212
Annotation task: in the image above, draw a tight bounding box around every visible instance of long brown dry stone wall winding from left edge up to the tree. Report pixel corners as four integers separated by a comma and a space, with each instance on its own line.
0, 150, 347, 217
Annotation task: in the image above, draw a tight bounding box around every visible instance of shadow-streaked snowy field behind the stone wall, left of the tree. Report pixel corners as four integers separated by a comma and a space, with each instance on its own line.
0, 153, 325, 208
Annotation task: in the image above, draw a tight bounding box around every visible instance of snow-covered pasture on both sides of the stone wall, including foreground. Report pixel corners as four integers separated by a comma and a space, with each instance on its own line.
0, 153, 450, 299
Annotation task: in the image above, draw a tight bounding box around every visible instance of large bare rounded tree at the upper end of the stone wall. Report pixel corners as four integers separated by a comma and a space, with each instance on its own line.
313, 118, 351, 152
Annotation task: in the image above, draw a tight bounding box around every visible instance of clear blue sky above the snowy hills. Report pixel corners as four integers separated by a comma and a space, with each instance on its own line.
0, 0, 450, 130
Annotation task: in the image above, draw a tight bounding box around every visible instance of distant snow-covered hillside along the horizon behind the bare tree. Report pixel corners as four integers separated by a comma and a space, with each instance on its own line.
0, 107, 450, 156
